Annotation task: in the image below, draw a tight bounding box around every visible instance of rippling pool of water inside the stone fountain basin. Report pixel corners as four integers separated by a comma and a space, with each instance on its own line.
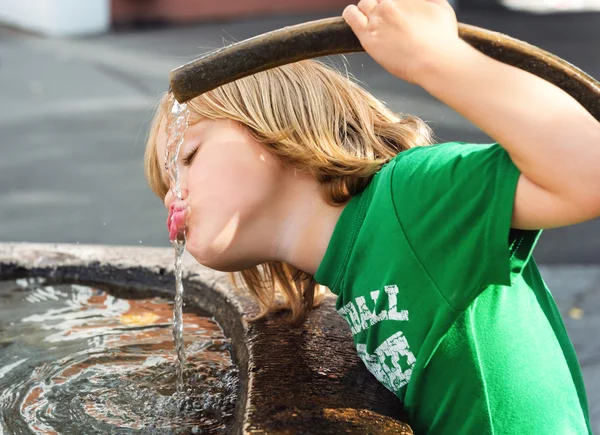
0, 278, 238, 435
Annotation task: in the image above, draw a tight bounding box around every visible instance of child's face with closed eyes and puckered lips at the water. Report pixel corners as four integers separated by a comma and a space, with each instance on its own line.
157, 119, 284, 271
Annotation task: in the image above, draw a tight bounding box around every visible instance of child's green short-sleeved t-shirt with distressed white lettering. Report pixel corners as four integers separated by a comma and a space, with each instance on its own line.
315, 143, 591, 435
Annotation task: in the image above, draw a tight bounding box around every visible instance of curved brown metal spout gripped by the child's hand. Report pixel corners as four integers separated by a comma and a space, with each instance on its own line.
170, 17, 600, 121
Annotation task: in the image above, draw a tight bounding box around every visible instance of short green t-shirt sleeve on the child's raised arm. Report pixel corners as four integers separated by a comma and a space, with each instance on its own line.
391, 143, 539, 309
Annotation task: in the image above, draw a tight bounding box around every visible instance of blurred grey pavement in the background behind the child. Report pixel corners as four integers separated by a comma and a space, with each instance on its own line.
0, 5, 600, 431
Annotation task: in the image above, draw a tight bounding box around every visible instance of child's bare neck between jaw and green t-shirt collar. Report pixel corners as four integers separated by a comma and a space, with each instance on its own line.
271, 173, 344, 275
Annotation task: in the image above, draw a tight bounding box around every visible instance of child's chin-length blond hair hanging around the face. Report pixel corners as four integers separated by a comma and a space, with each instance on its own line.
144, 60, 432, 324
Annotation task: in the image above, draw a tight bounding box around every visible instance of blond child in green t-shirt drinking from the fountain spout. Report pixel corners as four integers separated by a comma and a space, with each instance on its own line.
145, 0, 600, 435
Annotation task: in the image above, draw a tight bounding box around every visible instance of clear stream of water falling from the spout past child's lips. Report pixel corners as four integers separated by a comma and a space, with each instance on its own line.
165, 94, 190, 393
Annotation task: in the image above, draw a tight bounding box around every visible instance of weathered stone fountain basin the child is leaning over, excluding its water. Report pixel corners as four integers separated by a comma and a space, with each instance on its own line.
0, 243, 412, 434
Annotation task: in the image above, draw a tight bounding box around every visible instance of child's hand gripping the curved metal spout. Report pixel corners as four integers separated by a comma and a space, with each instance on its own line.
342, 0, 464, 84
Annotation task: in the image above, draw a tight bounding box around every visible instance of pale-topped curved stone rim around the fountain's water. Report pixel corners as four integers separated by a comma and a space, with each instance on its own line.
0, 243, 256, 433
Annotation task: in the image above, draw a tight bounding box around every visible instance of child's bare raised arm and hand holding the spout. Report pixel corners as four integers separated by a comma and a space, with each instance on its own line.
343, 0, 600, 229
